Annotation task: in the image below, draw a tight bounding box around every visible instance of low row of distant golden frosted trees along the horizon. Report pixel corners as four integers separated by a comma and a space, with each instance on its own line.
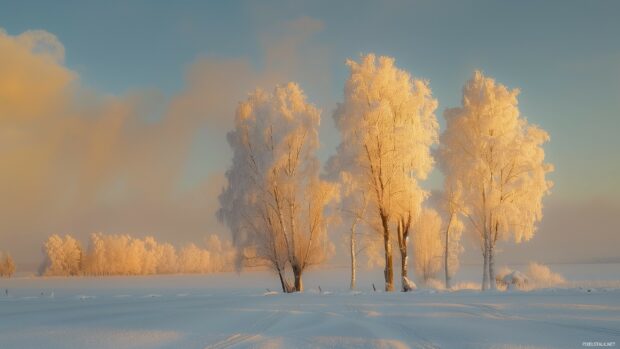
39, 233, 236, 276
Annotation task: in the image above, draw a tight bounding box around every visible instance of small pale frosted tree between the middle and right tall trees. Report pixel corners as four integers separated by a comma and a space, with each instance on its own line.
413, 209, 443, 283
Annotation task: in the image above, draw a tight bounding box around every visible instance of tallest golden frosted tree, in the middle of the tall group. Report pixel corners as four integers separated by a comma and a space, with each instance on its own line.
334, 54, 438, 291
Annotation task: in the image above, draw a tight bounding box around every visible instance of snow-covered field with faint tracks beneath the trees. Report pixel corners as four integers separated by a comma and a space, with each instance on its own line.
0, 265, 620, 348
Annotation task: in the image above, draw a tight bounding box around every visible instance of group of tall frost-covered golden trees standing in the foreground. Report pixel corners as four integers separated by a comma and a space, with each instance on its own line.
218, 54, 553, 292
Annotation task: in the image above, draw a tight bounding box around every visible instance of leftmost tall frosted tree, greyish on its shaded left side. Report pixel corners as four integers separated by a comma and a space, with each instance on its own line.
218, 83, 337, 292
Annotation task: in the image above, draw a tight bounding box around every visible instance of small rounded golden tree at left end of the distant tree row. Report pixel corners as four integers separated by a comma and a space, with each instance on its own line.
39, 234, 82, 276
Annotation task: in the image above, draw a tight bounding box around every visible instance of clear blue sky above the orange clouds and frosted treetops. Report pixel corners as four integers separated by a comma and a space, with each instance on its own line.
0, 0, 620, 260
